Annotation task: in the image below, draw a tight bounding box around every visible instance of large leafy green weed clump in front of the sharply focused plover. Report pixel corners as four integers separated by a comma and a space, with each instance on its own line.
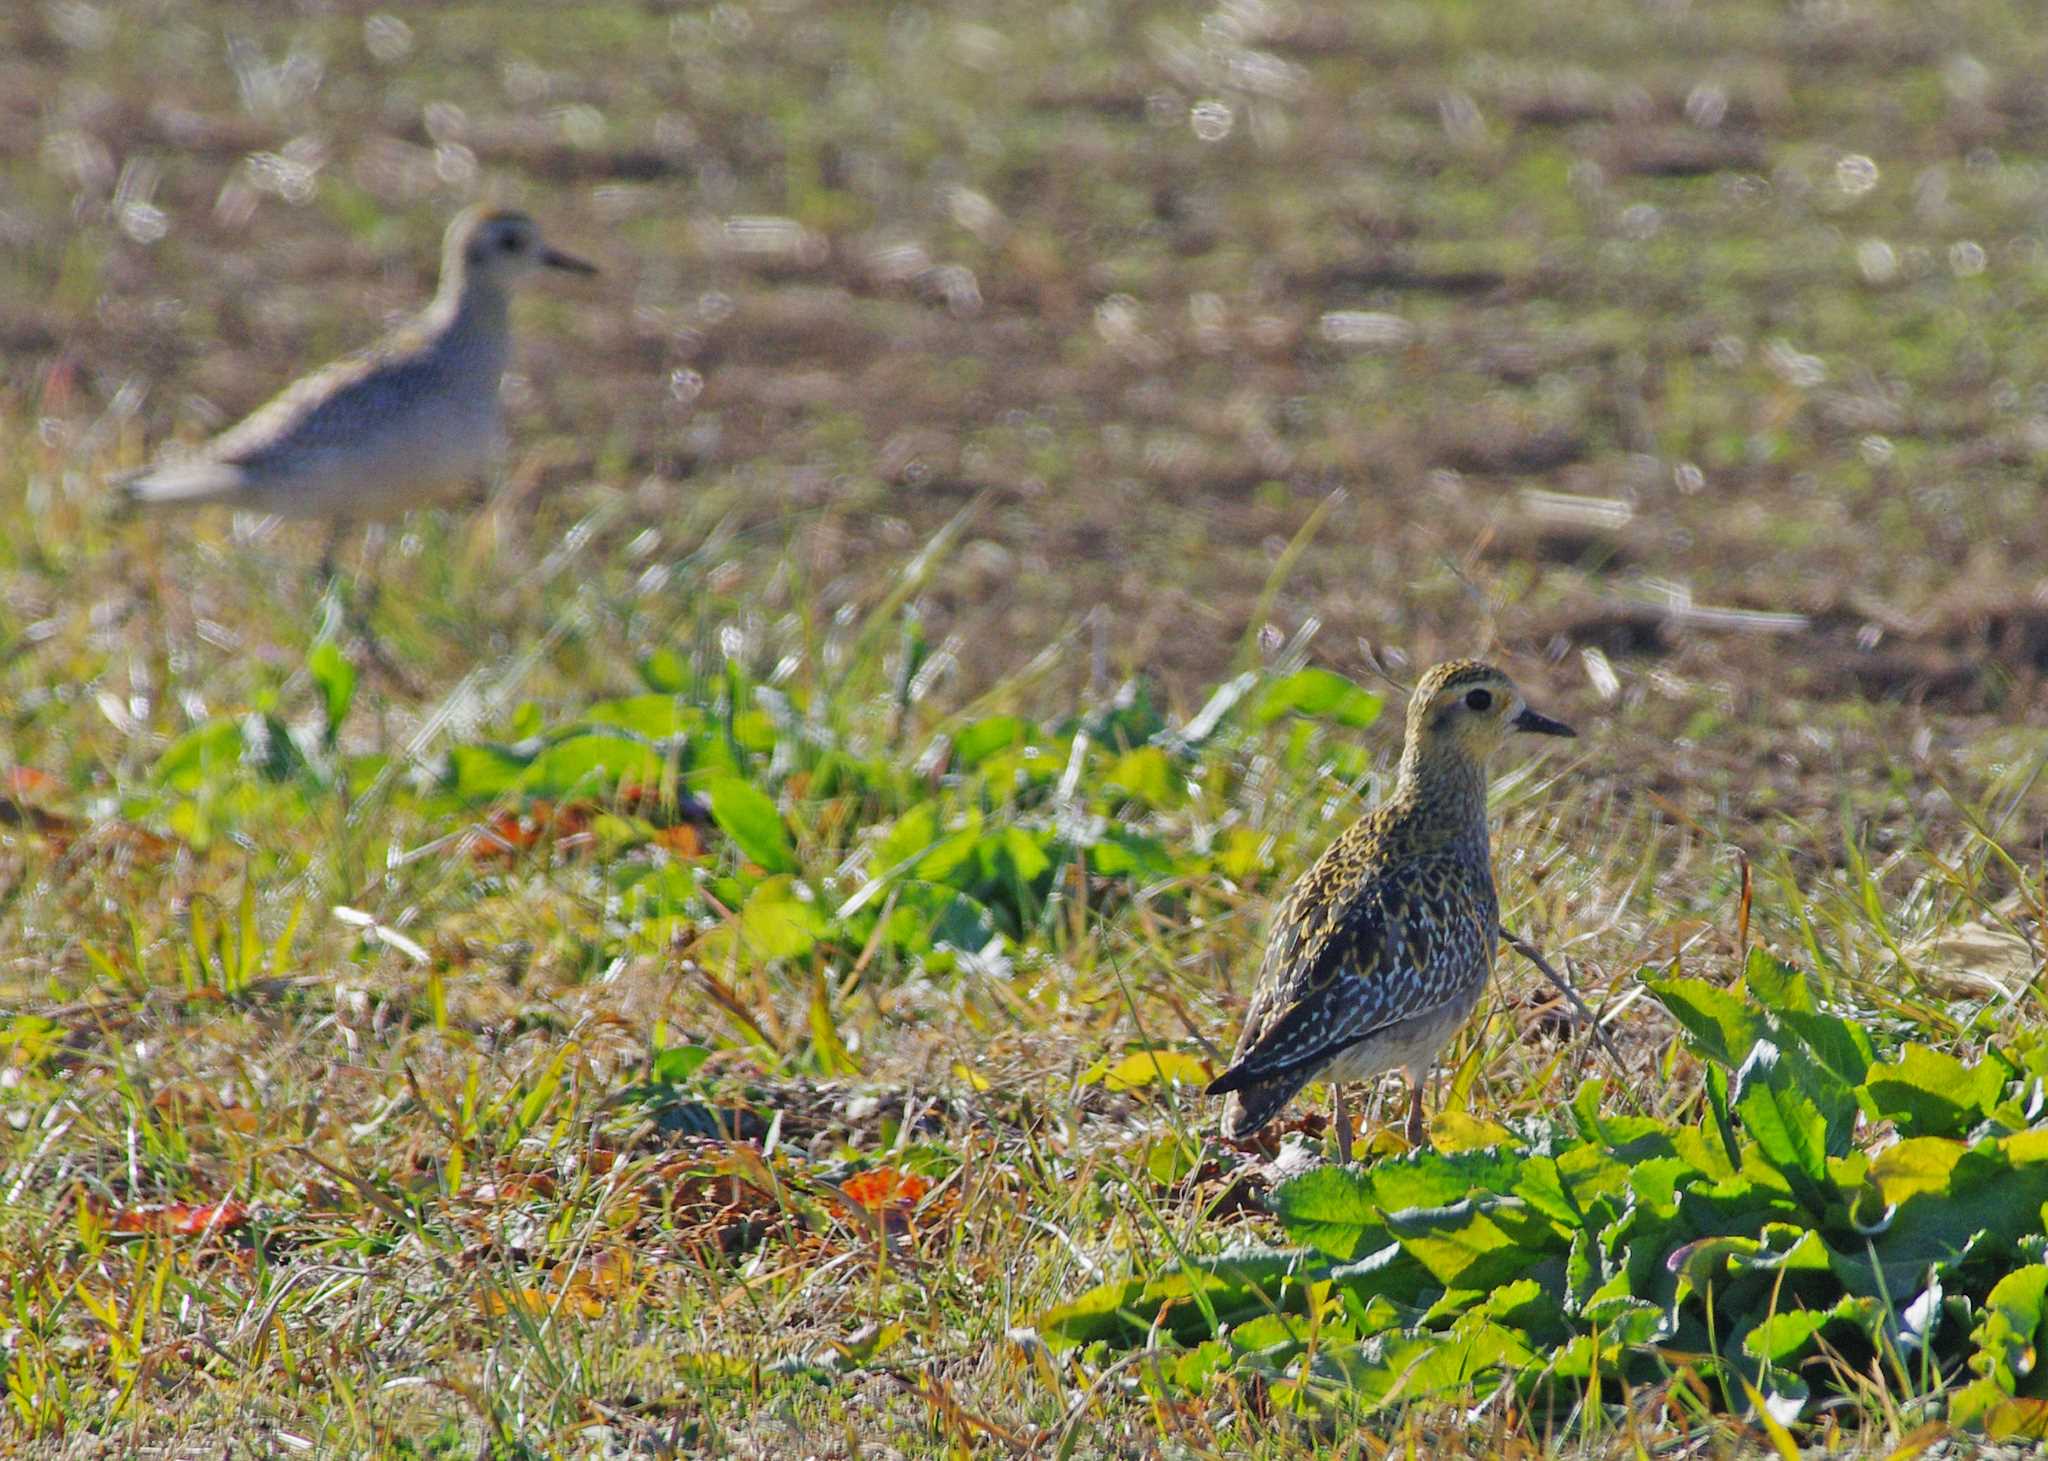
1042, 949, 2048, 1438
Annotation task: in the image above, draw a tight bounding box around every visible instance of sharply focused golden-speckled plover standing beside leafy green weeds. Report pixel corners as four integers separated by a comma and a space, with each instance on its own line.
1208, 660, 1577, 1162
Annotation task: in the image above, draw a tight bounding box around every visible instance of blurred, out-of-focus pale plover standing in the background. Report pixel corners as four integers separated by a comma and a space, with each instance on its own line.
117, 207, 598, 520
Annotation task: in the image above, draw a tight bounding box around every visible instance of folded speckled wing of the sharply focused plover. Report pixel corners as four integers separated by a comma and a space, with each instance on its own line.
1210, 857, 1495, 1094
